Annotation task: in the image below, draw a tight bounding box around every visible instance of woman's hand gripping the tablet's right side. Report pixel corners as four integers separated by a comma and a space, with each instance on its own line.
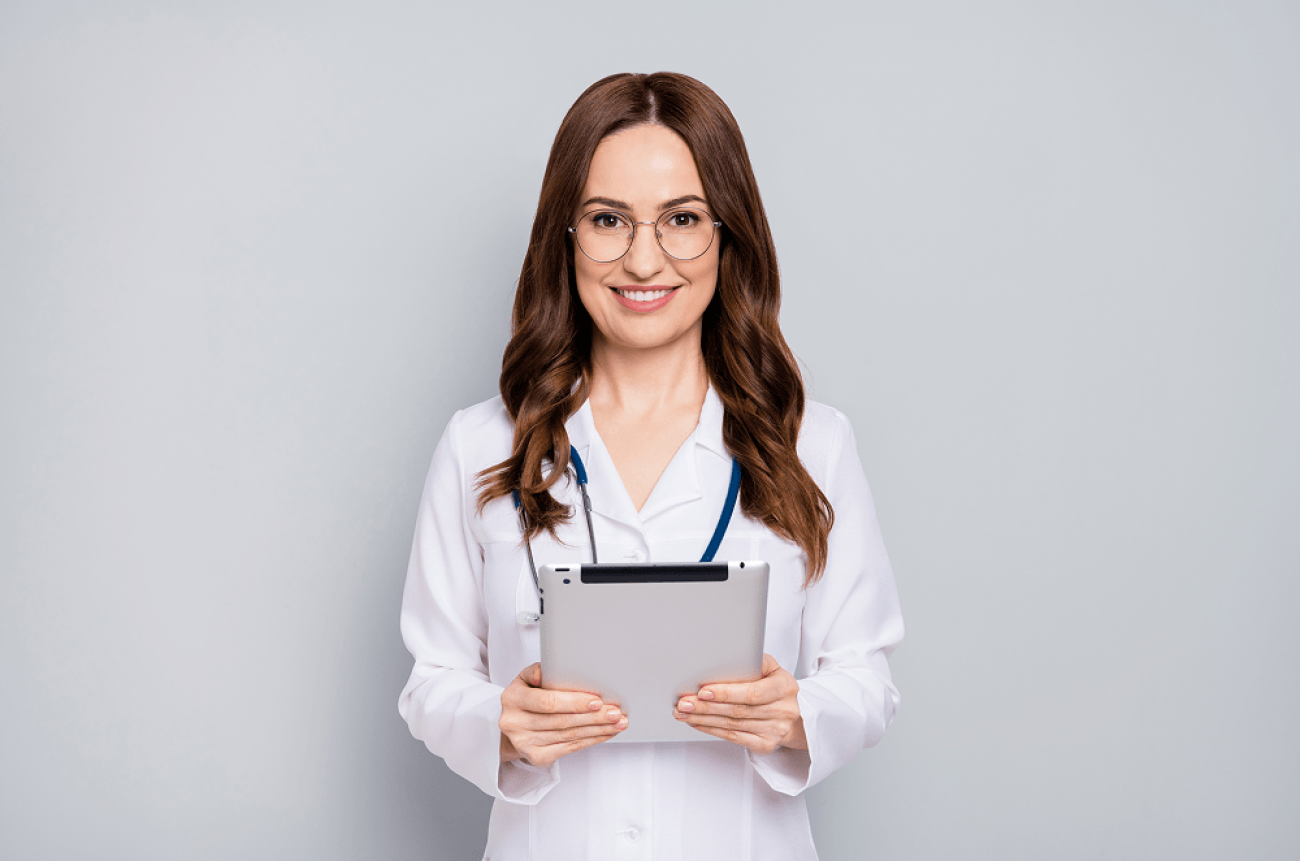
672, 654, 809, 753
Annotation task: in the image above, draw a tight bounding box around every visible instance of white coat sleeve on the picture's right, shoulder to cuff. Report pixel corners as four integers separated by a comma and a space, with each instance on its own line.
749, 412, 904, 796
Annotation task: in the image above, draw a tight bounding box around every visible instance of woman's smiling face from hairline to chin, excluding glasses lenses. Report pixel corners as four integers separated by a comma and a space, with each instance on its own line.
573, 125, 720, 350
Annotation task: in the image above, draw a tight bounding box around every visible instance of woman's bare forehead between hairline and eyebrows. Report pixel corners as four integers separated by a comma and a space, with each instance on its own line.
582, 125, 705, 209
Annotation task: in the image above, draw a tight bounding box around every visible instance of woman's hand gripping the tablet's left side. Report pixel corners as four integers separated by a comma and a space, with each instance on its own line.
498, 663, 628, 766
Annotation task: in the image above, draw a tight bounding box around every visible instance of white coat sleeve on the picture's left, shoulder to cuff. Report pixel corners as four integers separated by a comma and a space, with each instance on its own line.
398, 412, 559, 804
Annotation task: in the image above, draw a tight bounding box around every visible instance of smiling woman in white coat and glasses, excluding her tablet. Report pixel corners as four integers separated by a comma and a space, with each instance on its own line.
400, 73, 902, 861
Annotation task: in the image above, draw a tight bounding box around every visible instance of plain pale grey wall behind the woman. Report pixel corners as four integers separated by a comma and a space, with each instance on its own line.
0, 0, 1300, 861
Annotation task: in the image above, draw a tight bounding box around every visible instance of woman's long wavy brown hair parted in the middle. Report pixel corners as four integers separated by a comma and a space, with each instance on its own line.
477, 72, 835, 584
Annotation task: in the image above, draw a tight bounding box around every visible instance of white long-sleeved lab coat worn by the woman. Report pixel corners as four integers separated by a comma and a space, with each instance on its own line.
399, 388, 902, 861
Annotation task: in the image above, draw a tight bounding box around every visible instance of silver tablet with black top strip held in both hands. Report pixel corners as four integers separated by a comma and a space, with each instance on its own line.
538, 562, 767, 741
